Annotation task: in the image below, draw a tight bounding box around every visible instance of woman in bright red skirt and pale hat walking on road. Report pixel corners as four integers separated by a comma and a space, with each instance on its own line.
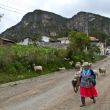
80, 62, 98, 107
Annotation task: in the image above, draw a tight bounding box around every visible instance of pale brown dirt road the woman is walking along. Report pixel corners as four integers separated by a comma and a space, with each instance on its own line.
0, 57, 110, 110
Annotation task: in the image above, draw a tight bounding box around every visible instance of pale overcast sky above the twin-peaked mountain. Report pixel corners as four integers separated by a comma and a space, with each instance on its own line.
0, 0, 110, 33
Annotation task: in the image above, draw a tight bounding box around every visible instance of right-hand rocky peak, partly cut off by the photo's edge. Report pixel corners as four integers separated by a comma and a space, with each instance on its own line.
67, 12, 110, 41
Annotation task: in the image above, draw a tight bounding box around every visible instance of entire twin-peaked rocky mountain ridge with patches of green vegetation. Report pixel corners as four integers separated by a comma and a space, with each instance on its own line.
1, 10, 110, 42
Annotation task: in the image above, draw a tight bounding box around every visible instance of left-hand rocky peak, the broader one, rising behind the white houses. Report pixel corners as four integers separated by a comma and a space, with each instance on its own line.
2, 10, 67, 41
